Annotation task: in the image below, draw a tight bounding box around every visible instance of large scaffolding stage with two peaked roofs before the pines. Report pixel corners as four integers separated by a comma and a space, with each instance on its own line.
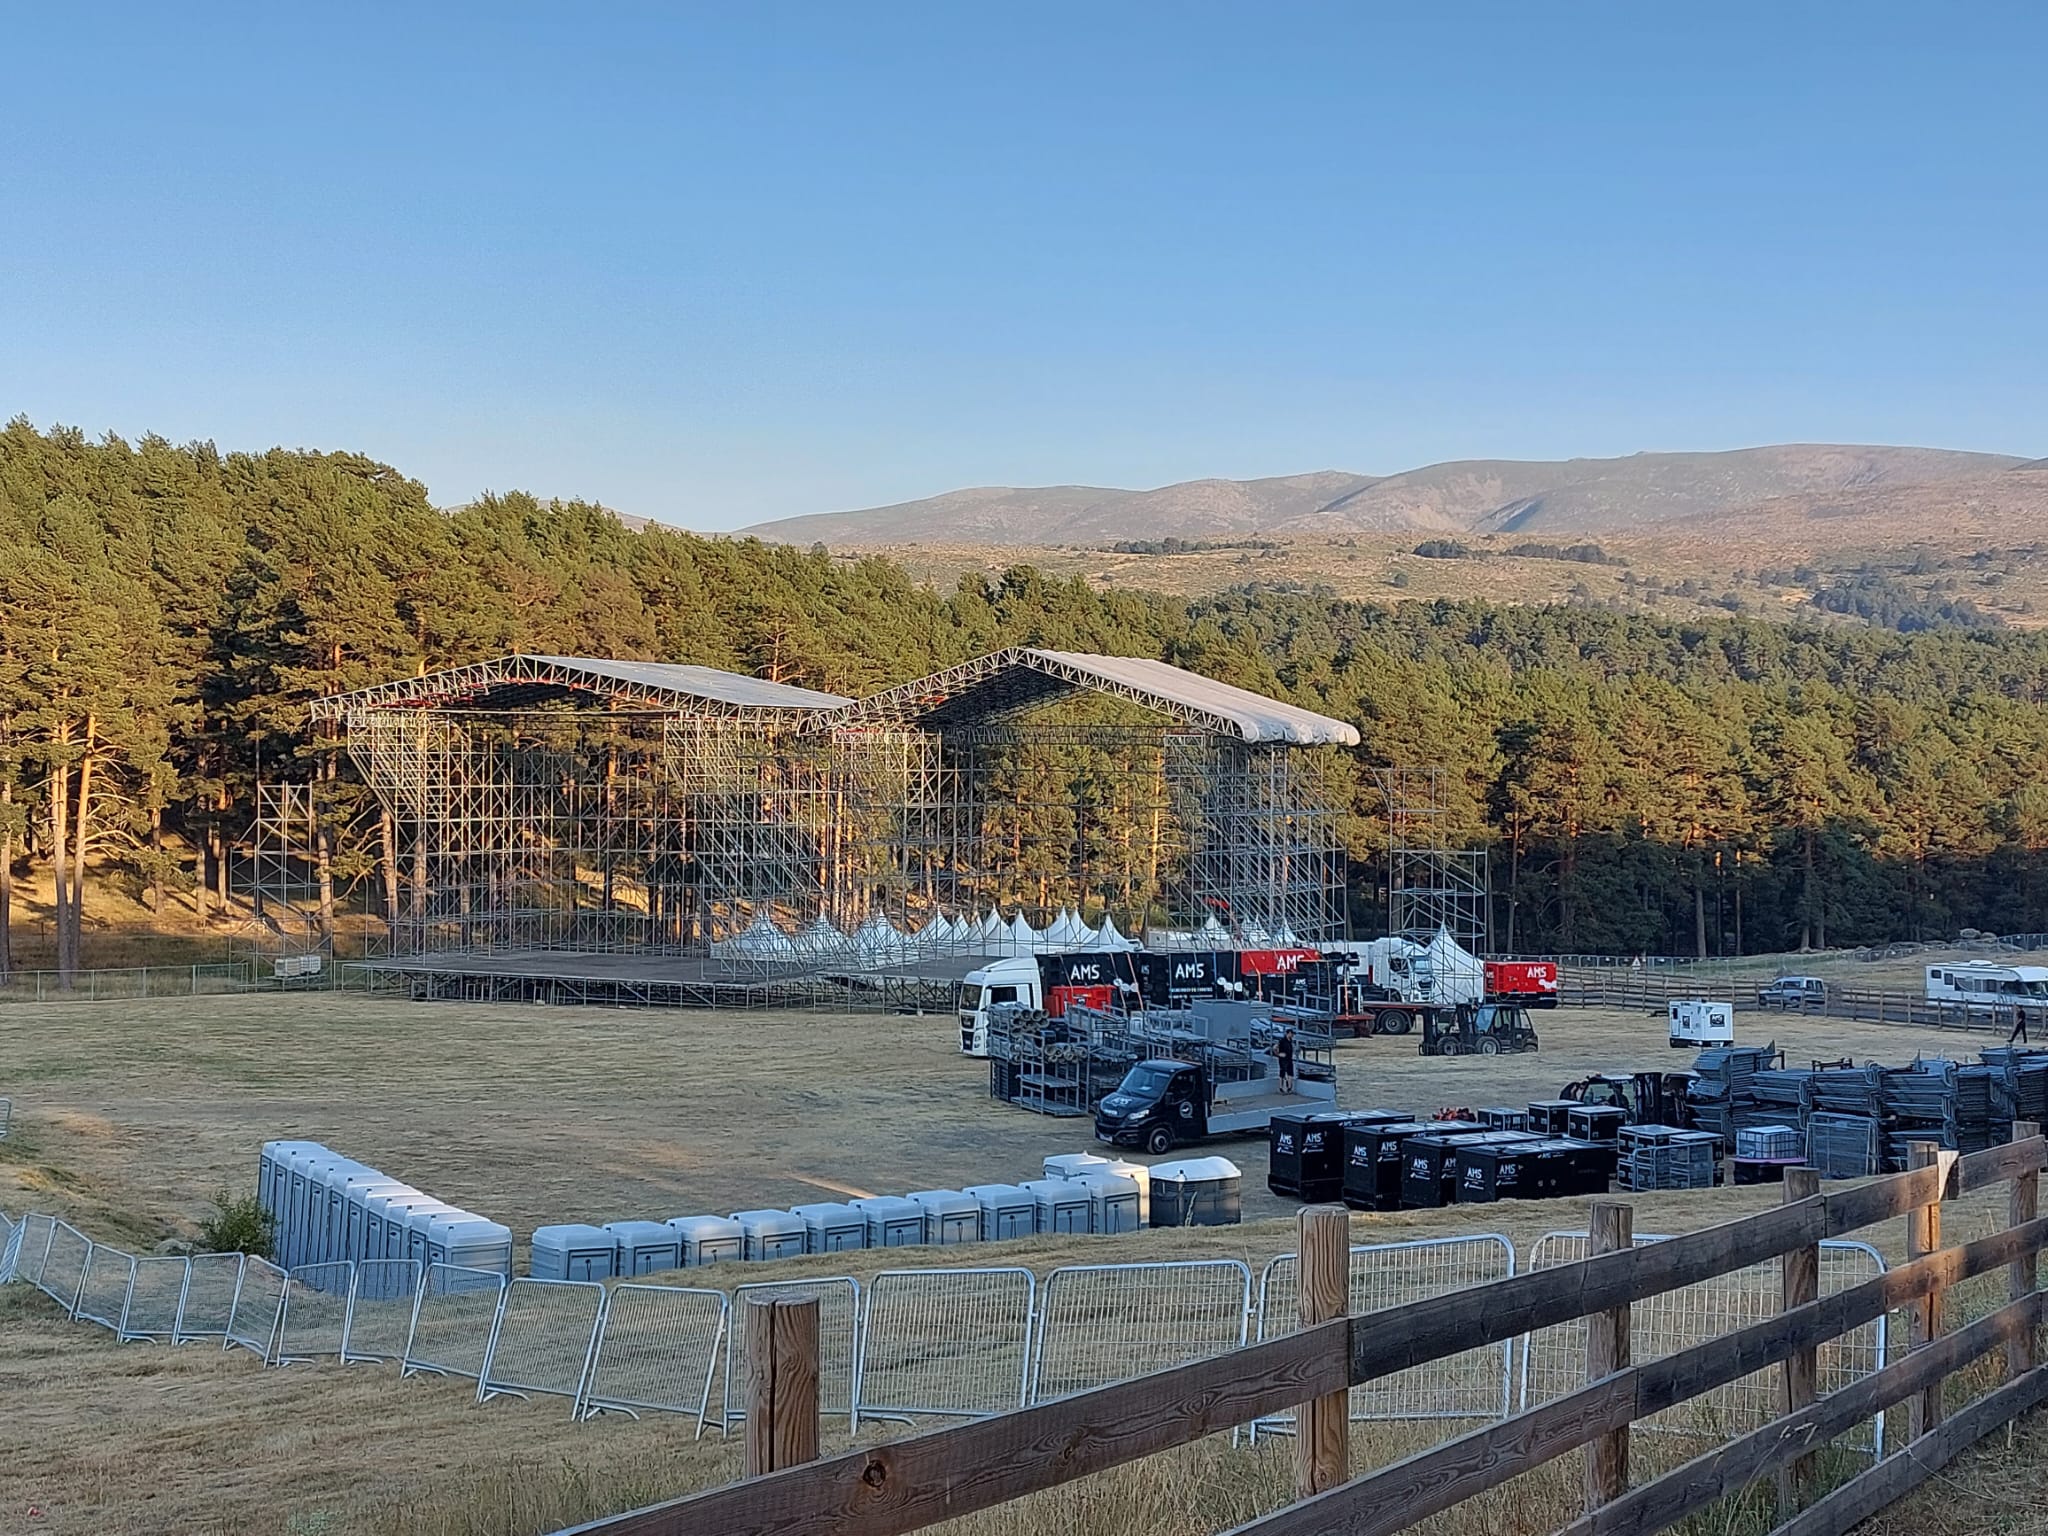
313, 649, 1358, 1001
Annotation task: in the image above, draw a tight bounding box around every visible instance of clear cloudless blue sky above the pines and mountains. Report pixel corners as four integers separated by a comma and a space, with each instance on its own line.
0, 0, 2048, 528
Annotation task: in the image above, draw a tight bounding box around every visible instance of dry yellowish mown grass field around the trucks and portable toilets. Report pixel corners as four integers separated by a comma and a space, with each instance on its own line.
0, 995, 2042, 1536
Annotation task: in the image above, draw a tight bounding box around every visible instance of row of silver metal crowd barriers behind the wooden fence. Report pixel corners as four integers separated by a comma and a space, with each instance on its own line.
0, 1212, 1886, 1454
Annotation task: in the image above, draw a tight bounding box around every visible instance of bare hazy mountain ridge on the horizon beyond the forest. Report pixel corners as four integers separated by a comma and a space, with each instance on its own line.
743, 442, 2048, 545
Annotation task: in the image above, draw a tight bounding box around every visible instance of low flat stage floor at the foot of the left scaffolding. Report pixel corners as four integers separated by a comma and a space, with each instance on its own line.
344, 950, 987, 1012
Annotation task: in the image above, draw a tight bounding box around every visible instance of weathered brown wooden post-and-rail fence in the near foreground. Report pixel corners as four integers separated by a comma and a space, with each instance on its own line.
569, 1124, 2048, 1536
